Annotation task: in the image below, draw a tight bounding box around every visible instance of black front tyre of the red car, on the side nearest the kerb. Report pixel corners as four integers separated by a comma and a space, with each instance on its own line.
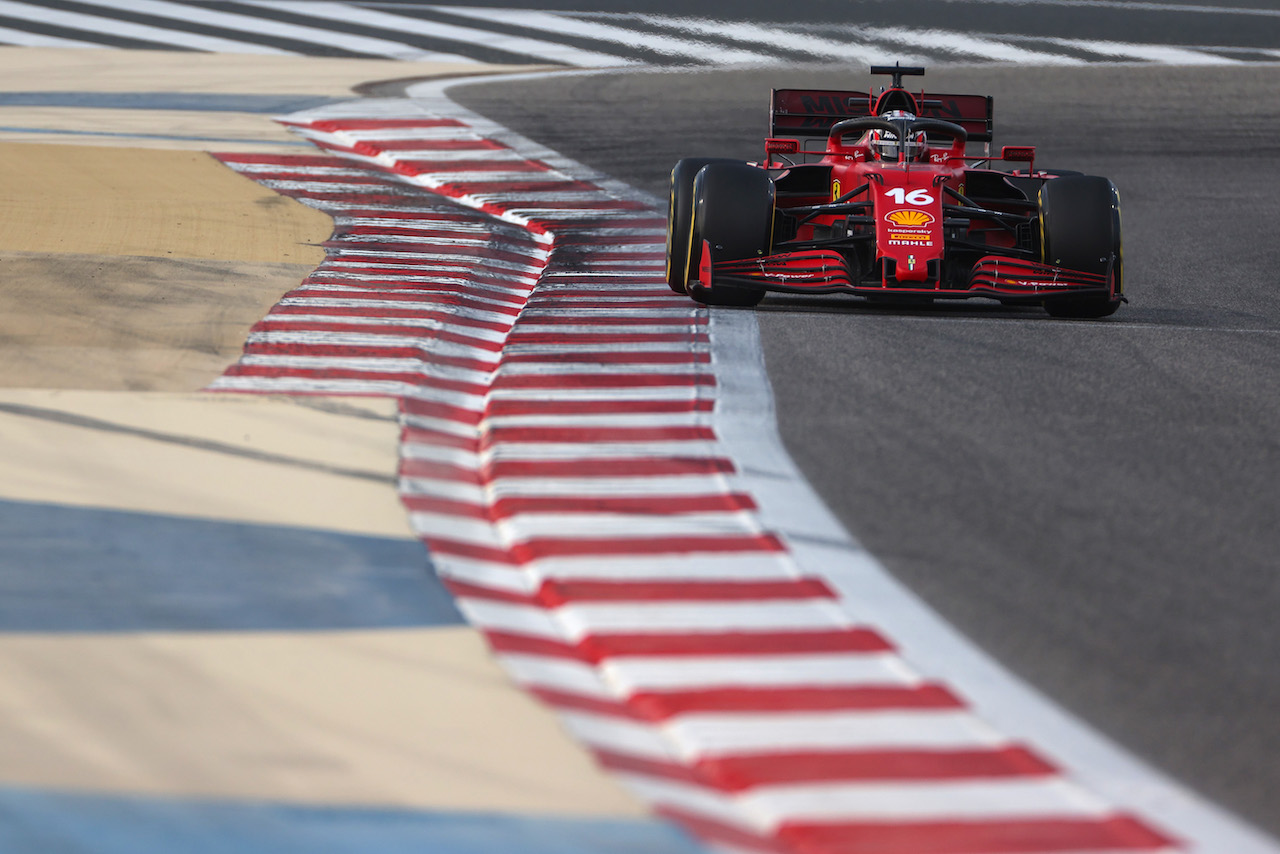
689, 163, 774, 306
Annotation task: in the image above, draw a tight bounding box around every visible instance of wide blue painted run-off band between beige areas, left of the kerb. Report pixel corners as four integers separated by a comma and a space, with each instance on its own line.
0, 501, 463, 632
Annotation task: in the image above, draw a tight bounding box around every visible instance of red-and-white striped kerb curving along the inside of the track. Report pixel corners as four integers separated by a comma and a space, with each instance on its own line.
211, 101, 1181, 853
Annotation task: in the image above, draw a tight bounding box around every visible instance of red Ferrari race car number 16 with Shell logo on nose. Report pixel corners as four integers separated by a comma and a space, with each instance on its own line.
667, 65, 1125, 318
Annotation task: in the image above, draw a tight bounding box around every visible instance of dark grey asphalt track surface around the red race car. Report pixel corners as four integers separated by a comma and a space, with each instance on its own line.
452, 67, 1280, 834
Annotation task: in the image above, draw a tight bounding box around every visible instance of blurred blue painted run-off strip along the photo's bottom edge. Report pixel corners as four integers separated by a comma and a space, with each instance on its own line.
0, 787, 705, 854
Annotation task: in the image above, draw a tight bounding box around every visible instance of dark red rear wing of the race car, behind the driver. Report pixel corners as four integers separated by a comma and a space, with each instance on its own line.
769, 88, 995, 162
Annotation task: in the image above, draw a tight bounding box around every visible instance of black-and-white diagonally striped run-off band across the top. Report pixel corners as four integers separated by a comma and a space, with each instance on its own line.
0, 0, 1280, 68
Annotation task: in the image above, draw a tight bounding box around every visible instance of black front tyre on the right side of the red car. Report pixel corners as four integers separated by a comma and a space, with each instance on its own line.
1039, 175, 1124, 318
